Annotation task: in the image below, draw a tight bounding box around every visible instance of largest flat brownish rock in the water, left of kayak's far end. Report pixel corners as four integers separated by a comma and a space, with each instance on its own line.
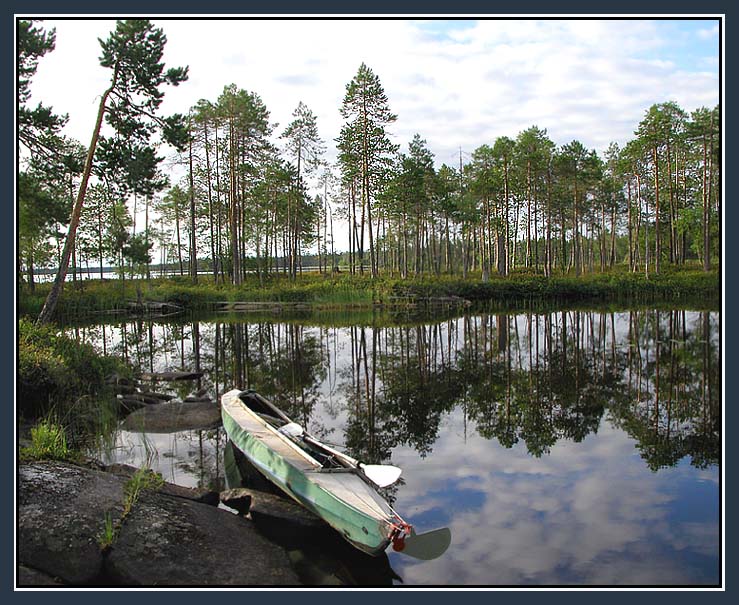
121, 401, 221, 433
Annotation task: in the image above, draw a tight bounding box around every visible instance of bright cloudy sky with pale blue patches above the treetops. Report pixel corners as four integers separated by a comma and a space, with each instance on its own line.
24, 16, 720, 251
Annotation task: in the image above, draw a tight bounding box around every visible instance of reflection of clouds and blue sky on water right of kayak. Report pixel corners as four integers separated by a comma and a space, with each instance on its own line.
392, 410, 719, 585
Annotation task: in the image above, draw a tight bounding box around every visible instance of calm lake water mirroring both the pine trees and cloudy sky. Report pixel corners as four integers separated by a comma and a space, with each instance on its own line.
69, 310, 721, 586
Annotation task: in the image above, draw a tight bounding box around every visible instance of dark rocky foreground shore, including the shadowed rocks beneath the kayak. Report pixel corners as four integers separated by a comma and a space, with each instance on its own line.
16, 461, 398, 587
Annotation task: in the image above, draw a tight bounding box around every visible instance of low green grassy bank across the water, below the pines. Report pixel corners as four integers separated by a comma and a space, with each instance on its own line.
19, 268, 721, 316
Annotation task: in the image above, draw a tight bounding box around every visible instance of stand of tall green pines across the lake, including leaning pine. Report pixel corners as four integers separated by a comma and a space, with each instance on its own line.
17, 19, 721, 320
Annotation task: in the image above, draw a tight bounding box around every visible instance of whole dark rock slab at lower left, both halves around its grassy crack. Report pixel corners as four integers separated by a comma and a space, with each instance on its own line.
18, 462, 300, 586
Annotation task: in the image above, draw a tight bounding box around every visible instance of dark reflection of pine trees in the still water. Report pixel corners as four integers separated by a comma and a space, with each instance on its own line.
70, 310, 721, 488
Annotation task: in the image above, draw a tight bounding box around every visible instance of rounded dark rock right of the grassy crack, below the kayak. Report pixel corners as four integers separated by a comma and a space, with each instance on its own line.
106, 492, 300, 586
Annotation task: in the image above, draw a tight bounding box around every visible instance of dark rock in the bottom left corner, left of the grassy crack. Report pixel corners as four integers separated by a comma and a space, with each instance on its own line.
18, 462, 124, 584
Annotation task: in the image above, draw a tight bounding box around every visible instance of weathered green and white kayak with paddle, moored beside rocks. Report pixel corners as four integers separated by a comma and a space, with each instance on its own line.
221, 389, 451, 560
